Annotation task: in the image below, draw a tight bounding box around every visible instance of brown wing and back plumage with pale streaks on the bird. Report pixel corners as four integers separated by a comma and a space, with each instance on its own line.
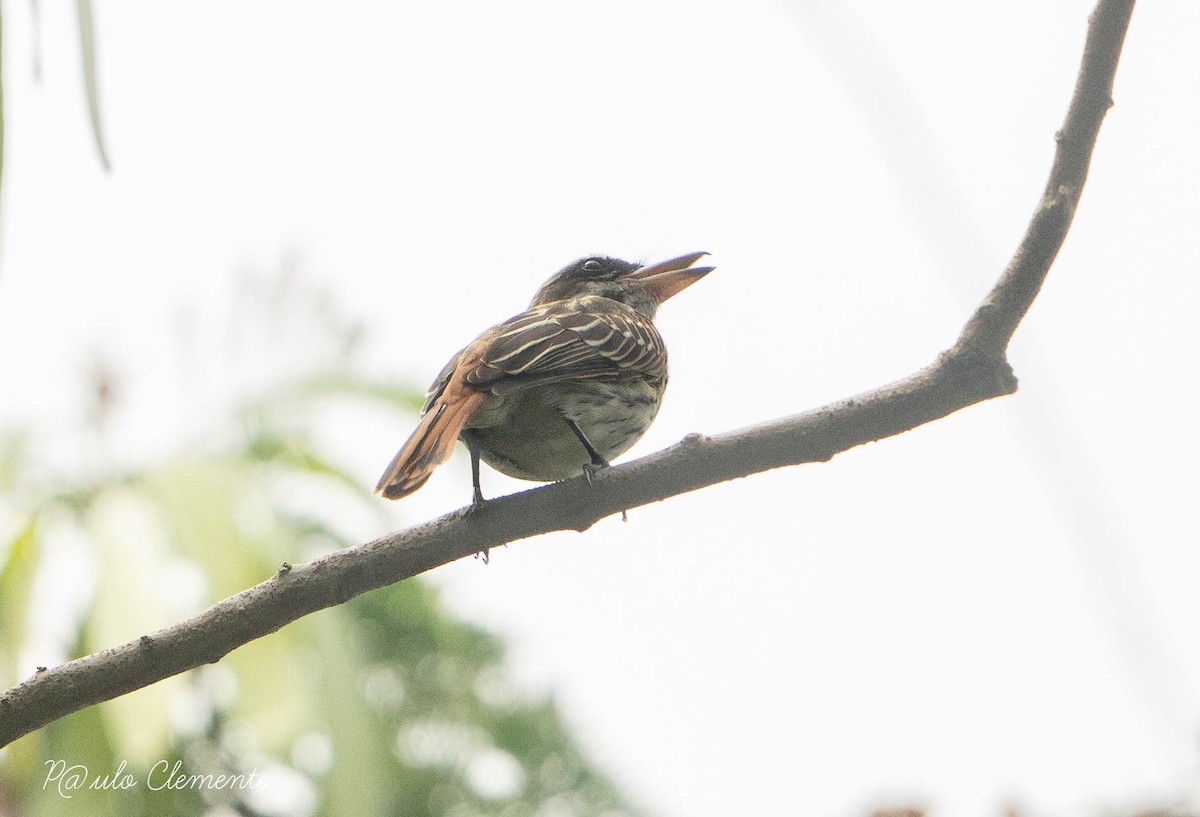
456, 296, 667, 394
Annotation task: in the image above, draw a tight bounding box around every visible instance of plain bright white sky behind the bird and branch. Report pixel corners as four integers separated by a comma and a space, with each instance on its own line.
0, 0, 1200, 817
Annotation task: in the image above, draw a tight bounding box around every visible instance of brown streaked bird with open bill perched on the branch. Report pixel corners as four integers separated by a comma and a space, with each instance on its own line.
376, 252, 714, 503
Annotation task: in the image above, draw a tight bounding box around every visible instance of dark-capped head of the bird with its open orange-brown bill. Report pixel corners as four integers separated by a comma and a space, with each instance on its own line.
530, 252, 714, 318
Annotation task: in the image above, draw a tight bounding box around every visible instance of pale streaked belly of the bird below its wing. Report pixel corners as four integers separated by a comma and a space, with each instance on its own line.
463, 380, 662, 482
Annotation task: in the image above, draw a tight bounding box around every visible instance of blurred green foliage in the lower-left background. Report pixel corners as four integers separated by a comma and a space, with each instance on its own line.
0, 272, 635, 817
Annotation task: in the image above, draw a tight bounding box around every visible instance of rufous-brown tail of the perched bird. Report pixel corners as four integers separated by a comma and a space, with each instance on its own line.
376, 390, 487, 499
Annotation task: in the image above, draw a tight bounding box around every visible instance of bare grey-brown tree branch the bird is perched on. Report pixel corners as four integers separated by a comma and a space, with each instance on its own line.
0, 0, 1133, 746
